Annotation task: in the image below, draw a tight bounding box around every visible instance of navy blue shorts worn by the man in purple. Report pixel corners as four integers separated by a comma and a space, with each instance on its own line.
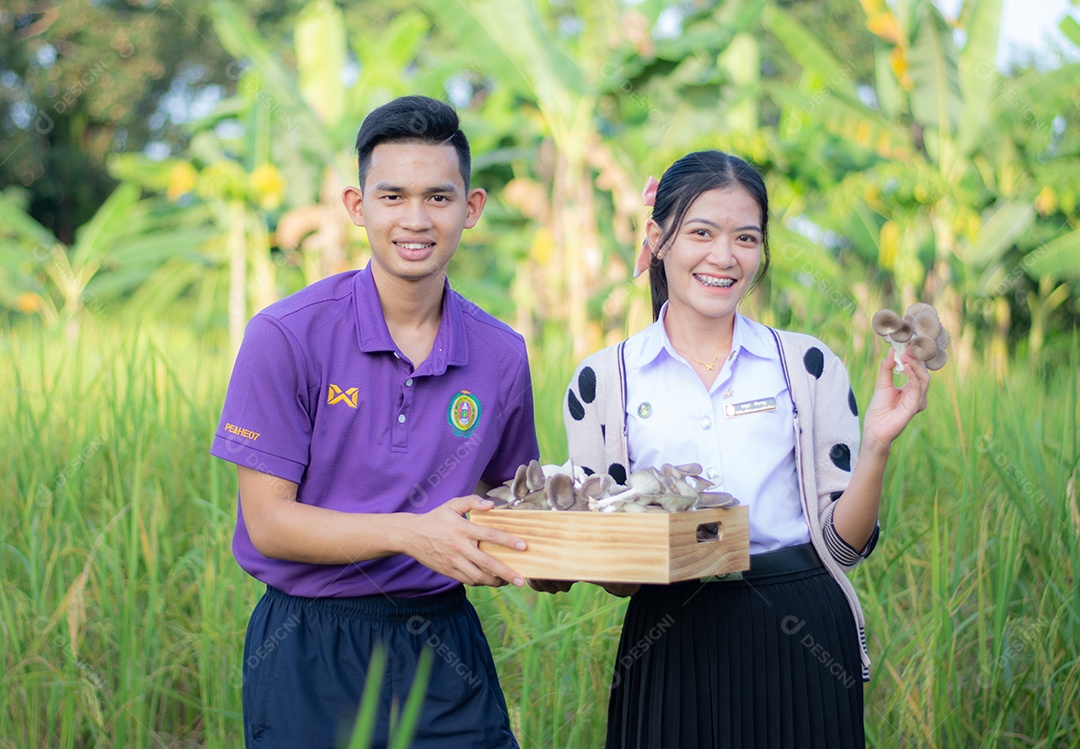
243, 587, 517, 749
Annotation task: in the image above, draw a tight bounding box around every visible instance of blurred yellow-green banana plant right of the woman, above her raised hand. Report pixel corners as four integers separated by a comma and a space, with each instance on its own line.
766, 0, 1080, 363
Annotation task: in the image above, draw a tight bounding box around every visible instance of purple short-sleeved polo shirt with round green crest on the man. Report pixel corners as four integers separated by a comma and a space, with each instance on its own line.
211, 265, 539, 598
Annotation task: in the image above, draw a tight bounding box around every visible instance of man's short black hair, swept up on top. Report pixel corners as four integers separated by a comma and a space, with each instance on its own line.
356, 96, 472, 191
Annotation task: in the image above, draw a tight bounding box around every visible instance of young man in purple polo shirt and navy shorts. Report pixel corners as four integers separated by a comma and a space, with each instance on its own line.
211, 96, 539, 749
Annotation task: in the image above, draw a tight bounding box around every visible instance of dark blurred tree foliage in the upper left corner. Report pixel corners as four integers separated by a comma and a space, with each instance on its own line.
0, 0, 228, 243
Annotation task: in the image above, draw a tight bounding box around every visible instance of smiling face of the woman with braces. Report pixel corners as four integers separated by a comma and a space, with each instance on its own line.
648, 185, 764, 327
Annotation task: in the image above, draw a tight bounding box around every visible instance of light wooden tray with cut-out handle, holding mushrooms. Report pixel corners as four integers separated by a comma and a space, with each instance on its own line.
470, 505, 750, 583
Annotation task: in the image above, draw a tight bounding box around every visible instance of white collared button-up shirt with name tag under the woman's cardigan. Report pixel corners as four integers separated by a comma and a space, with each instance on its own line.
625, 305, 810, 554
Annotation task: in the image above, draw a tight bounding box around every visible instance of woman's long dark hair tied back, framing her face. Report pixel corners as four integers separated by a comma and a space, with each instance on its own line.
649, 151, 769, 319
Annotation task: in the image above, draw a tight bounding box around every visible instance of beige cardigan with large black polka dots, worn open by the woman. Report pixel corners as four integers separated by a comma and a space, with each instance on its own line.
563, 328, 878, 681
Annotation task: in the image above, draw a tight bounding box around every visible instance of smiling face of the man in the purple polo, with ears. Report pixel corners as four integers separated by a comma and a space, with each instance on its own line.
342, 141, 486, 285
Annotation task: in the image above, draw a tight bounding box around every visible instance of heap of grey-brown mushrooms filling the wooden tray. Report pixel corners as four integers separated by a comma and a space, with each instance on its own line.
487, 461, 739, 513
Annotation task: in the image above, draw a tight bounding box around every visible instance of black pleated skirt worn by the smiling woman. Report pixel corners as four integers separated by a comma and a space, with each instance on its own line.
607, 568, 865, 749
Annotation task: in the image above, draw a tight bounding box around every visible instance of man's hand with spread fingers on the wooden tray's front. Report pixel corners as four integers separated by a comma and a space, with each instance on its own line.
402, 494, 525, 587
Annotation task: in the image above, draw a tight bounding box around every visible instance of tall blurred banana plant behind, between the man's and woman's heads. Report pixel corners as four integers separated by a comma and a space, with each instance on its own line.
424, 0, 777, 357
